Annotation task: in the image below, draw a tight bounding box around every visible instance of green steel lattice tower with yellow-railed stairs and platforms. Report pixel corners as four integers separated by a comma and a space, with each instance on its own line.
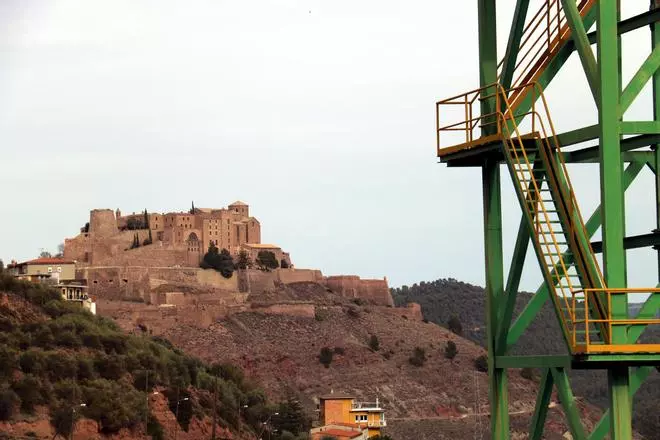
436, 0, 660, 440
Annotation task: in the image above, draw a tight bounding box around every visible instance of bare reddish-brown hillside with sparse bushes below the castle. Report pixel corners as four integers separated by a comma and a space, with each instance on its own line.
99, 283, 612, 440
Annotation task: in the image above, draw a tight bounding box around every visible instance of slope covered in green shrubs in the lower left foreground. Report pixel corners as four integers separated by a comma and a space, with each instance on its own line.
0, 275, 300, 439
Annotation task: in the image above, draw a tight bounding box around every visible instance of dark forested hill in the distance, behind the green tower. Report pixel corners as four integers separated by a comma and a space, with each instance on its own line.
392, 279, 660, 438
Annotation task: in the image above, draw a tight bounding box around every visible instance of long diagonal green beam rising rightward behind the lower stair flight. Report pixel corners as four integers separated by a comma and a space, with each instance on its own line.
506, 162, 644, 349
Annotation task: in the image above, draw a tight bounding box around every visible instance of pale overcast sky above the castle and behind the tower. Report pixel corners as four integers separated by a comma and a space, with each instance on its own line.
0, 0, 657, 290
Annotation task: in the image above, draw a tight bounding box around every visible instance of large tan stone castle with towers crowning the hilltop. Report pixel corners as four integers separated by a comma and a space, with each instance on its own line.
64, 201, 291, 267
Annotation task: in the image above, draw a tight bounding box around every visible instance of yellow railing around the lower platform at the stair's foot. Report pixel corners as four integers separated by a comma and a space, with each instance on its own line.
571, 288, 660, 353
